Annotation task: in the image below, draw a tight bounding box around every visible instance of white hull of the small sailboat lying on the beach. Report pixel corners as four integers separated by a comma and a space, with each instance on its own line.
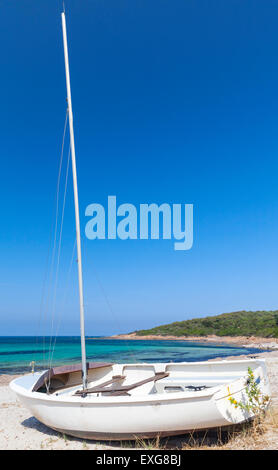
11, 360, 269, 440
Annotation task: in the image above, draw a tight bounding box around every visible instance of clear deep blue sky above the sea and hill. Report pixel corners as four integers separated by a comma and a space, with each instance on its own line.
0, 0, 278, 335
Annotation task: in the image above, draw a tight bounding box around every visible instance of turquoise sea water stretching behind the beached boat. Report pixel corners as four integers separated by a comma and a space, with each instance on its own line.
0, 336, 260, 374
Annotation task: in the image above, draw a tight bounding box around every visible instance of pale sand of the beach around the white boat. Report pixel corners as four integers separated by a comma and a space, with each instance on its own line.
0, 351, 278, 450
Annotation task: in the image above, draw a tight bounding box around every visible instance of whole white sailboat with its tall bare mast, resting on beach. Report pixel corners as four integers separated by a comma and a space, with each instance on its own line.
10, 12, 269, 440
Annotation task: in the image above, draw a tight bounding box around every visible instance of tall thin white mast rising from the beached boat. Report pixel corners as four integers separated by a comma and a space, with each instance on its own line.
62, 12, 87, 390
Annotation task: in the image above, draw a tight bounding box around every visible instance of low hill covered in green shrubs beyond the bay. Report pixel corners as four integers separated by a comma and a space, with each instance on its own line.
135, 310, 278, 338
